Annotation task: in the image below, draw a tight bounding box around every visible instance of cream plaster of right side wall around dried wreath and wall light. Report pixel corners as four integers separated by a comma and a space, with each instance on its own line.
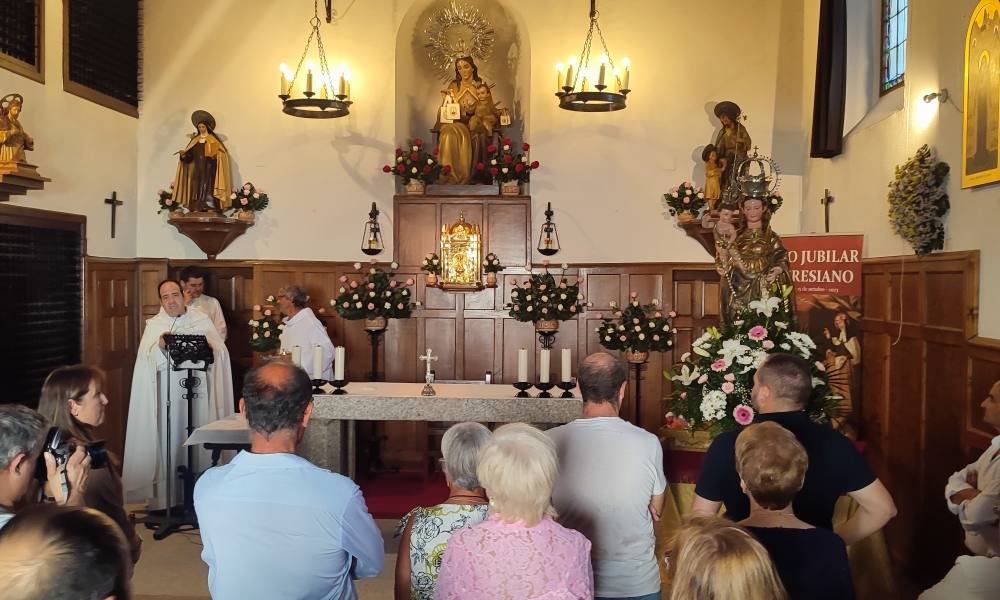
803, 0, 1000, 338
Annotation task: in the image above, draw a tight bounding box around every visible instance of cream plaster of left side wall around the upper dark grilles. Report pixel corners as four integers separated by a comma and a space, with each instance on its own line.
0, 0, 138, 257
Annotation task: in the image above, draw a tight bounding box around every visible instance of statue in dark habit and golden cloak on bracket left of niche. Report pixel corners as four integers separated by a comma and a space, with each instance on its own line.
173, 110, 232, 213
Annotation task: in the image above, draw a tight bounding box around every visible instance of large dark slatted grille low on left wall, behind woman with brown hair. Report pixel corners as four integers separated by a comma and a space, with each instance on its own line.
0, 221, 82, 406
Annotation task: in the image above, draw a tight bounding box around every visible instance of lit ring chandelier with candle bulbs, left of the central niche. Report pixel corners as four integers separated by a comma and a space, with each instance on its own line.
278, 0, 352, 119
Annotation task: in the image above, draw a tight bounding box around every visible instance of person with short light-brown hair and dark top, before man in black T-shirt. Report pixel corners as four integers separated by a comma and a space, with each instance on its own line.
736, 421, 854, 600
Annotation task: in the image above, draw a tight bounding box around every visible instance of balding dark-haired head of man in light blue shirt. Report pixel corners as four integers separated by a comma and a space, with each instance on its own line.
243, 361, 312, 437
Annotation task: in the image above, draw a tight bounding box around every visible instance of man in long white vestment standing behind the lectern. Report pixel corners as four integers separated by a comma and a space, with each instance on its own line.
122, 280, 234, 510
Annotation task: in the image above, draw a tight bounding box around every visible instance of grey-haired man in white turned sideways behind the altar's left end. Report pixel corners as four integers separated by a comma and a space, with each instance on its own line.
276, 285, 333, 381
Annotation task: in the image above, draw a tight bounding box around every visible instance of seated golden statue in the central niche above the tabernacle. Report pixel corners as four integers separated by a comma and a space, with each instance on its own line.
436, 56, 504, 184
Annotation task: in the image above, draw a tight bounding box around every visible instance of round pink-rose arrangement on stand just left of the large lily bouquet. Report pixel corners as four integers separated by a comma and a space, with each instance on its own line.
594, 292, 677, 352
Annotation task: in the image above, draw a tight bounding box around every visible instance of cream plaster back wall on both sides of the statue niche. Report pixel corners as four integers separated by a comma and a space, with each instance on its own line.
137, 0, 808, 262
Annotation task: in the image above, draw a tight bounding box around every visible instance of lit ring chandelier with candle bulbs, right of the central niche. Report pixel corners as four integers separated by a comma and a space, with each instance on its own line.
556, 0, 631, 112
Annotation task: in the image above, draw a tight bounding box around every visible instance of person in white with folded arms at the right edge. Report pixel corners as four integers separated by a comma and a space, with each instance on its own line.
944, 381, 1000, 556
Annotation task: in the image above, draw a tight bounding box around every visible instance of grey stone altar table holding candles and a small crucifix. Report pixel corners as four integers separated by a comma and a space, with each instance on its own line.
186, 382, 583, 477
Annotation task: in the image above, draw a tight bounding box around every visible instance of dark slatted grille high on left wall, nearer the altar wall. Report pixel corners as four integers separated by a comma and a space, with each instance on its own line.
66, 0, 140, 107
